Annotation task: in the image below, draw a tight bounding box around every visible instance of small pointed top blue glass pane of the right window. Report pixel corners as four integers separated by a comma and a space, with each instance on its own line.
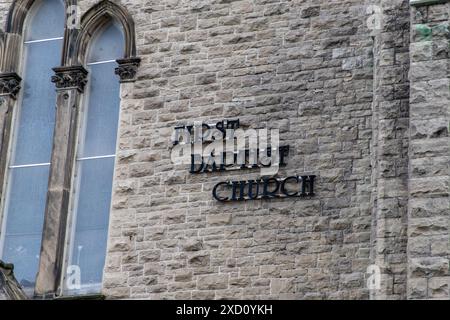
87, 23, 125, 63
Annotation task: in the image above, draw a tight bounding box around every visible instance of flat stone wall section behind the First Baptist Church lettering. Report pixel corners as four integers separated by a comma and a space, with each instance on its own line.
104, 0, 373, 299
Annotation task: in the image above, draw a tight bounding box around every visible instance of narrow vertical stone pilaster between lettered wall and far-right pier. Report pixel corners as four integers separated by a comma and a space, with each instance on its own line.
371, 0, 409, 299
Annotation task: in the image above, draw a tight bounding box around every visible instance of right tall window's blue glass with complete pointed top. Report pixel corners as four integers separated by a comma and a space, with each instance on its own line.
66, 21, 125, 293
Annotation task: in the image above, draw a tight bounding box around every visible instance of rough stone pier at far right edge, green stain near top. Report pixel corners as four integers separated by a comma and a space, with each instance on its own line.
408, 0, 450, 299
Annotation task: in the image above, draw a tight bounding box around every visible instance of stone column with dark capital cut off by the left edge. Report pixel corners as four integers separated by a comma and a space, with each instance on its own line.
0, 72, 22, 199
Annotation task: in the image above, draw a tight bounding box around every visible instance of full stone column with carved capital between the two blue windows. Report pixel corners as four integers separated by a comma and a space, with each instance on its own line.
35, 66, 88, 298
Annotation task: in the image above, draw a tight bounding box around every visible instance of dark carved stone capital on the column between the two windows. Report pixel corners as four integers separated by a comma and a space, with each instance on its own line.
52, 66, 88, 92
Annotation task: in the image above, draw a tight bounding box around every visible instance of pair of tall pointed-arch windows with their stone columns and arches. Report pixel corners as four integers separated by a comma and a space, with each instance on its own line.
0, 0, 140, 297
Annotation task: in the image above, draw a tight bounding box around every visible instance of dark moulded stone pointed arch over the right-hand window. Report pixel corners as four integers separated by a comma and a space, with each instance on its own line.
71, 0, 136, 64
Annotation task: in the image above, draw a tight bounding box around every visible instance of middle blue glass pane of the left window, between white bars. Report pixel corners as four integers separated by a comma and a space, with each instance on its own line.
12, 40, 62, 165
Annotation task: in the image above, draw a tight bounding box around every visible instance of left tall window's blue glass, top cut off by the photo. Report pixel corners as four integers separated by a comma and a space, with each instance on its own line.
0, 0, 65, 288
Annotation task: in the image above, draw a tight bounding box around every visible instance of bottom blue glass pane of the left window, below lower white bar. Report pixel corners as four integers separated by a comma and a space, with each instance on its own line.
3, 166, 49, 284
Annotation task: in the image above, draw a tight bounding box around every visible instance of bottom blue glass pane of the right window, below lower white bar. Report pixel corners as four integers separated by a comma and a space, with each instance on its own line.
71, 158, 115, 285
